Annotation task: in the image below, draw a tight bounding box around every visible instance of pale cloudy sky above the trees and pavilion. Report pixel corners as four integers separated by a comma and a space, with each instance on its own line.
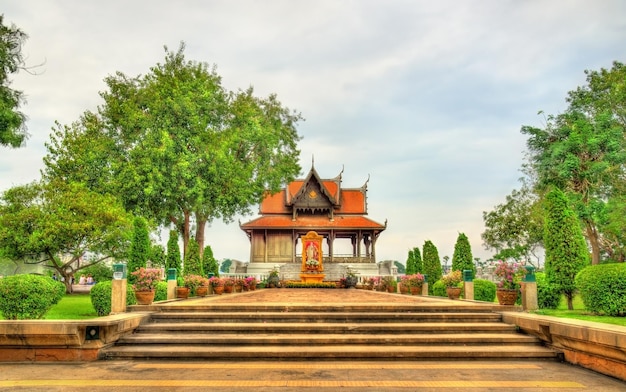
0, 0, 626, 262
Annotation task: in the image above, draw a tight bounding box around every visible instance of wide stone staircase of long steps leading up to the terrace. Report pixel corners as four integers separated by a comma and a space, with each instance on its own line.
100, 303, 559, 360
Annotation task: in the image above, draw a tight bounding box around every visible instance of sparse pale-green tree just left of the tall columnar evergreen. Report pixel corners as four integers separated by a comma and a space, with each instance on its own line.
481, 184, 543, 264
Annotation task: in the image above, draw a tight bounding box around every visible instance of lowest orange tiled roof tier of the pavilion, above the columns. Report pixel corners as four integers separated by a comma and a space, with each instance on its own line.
241, 215, 385, 230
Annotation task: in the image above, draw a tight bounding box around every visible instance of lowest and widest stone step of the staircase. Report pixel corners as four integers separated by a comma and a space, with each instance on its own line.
102, 344, 557, 360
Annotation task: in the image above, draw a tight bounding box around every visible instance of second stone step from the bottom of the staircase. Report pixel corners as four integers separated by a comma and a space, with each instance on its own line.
118, 333, 539, 349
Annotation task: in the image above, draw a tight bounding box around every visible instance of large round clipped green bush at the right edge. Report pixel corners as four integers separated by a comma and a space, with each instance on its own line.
575, 263, 626, 317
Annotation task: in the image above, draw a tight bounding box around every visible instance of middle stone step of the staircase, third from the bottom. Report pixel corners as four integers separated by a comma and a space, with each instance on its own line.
136, 322, 515, 334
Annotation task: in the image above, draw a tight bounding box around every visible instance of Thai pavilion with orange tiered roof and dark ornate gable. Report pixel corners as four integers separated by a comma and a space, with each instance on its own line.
240, 166, 391, 280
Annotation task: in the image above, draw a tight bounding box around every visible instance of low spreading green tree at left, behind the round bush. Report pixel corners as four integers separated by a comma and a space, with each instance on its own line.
0, 183, 132, 293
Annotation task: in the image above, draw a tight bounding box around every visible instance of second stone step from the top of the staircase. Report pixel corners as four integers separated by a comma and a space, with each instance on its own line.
152, 311, 502, 323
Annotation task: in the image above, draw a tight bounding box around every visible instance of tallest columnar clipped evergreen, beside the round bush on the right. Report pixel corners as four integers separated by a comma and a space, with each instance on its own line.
543, 188, 589, 310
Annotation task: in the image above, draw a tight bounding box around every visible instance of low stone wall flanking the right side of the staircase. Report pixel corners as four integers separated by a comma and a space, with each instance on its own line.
502, 312, 626, 381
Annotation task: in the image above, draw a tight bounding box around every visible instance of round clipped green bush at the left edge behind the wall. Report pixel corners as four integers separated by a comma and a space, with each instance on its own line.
0, 275, 65, 320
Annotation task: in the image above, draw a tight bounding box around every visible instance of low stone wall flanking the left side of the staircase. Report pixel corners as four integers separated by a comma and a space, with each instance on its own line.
0, 312, 150, 362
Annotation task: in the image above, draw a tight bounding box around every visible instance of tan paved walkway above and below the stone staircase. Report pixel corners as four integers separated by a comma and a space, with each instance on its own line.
0, 289, 626, 392
